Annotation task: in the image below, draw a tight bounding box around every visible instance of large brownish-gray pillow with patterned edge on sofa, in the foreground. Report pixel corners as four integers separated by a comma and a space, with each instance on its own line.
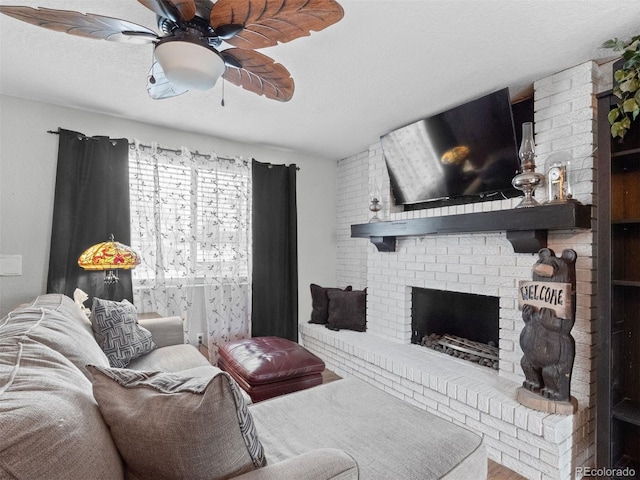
88, 366, 265, 480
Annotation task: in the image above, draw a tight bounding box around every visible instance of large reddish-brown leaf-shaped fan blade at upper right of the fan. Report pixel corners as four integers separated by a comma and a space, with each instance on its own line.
209, 0, 344, 48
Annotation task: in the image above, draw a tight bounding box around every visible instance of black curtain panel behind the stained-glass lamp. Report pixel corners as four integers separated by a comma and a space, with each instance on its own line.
47, 129, 133, 308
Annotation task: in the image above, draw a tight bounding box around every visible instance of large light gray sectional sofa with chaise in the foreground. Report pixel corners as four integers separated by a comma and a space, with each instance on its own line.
0, 294, 487, 480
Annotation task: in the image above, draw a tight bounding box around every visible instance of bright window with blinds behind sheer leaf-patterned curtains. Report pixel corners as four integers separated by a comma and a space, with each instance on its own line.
129, 142, 251, 286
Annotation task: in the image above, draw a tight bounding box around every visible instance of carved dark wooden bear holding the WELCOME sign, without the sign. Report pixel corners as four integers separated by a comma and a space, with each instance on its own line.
520, 248, 577, 402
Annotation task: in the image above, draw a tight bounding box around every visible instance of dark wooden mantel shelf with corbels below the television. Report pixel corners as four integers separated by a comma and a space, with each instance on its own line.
351, 202, 591, 253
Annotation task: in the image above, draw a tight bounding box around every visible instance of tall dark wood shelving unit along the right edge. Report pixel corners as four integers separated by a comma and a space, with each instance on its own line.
596, 92, 640, 467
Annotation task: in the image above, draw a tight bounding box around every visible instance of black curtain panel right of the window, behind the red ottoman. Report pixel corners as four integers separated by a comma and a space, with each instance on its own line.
251, 160, 298, 342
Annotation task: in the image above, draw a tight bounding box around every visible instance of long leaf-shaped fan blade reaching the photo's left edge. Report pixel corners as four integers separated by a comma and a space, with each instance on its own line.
0, 6, 158, 43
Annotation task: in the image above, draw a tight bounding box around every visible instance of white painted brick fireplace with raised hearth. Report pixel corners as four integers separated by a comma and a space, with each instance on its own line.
301, 62, 610, 480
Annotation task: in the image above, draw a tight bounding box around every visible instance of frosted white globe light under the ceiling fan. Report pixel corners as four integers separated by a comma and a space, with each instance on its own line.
155, 39, 225, 90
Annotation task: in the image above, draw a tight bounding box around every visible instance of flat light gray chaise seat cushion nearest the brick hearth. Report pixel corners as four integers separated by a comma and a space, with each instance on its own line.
249, 378, 487, 480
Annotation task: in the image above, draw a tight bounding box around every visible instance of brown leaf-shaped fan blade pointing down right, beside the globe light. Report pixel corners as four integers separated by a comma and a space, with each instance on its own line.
220, 48, 294, 102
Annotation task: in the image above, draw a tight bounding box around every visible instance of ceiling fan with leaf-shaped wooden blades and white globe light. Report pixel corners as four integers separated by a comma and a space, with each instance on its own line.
0, 0, 344, 102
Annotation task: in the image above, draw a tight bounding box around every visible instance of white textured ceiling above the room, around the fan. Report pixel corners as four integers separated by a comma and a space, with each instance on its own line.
0, 0, 640, 159
